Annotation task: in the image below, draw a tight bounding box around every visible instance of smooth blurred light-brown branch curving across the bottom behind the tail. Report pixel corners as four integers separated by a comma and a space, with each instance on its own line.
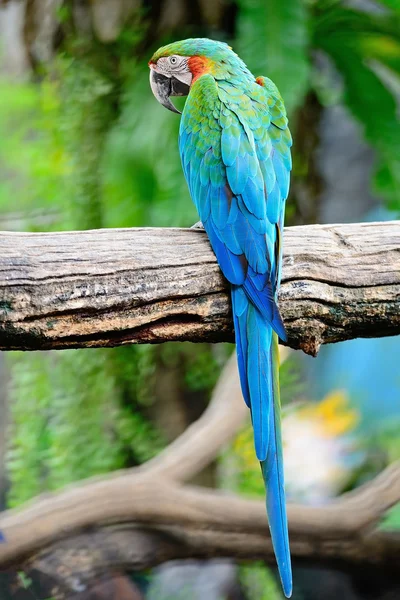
0, 464, 400, 569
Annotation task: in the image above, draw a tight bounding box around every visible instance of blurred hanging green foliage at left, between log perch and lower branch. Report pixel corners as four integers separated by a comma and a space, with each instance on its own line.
7, 350, 161, 506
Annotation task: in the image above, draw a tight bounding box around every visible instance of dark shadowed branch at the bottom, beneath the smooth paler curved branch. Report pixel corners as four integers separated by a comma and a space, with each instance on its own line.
25, 520, 400, 598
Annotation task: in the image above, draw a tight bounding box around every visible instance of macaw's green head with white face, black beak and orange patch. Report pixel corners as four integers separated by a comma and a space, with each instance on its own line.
149, 38, 254, 114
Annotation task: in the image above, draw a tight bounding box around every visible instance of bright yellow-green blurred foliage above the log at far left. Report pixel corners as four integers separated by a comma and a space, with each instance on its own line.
0, 58, 113, 230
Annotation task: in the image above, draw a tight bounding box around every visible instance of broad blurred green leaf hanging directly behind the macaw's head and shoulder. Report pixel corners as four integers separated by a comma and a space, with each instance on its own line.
237, 0, 309, 112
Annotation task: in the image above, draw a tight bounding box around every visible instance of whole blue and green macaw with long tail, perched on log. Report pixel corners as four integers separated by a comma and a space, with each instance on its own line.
149, 39, 292, 598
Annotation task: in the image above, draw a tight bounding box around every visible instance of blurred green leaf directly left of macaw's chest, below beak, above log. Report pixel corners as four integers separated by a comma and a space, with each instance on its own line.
102, 64, 198, 227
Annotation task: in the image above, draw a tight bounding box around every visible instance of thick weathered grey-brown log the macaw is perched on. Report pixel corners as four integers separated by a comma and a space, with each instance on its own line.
0, 221, 400, 354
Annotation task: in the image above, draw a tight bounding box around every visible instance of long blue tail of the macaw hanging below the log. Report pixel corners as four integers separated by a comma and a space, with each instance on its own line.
232, 286, 292, 598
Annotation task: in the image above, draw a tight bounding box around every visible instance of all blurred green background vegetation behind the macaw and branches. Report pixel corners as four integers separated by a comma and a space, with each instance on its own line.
0, 0, 400, 598
